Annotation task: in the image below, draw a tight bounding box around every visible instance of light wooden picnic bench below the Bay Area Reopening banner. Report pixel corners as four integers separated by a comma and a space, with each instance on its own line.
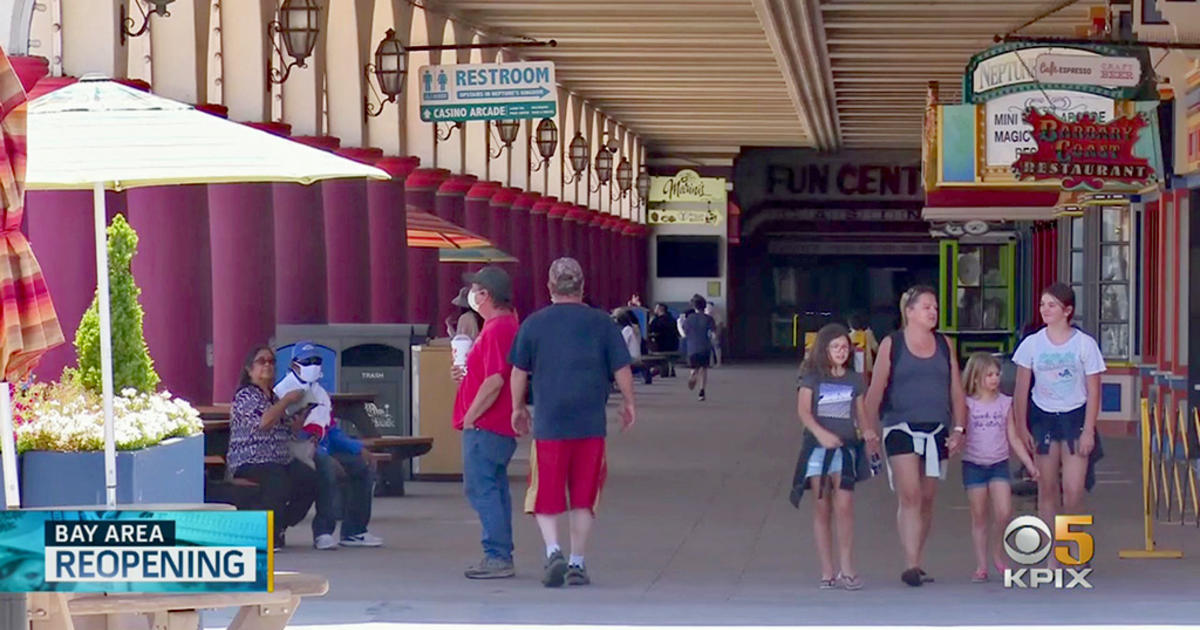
29, 571, 329, 630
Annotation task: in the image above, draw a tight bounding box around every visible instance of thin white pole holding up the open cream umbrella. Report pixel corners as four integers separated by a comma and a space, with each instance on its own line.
92, 182, 116, 508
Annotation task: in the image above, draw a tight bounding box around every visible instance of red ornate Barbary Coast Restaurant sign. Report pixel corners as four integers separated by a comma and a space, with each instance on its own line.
1013, 109, 1154, 191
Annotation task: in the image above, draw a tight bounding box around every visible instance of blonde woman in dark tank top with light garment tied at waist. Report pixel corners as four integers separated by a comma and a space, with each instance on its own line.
863, 287, 966, 587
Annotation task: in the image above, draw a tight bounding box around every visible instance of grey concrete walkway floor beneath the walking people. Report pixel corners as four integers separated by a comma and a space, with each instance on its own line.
205, 365, 1200, 628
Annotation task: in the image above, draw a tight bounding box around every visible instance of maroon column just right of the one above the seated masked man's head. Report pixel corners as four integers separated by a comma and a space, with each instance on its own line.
322, 148, 383, 324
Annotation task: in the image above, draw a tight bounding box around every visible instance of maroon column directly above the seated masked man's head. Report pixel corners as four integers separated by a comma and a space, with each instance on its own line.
253, 122, 329, 324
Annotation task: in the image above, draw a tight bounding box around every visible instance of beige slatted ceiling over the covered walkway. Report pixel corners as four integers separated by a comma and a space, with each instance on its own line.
424, 0, 1104, 164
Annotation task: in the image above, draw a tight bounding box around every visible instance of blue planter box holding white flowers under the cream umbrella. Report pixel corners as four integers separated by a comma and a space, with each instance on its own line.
20, 434, 204, 508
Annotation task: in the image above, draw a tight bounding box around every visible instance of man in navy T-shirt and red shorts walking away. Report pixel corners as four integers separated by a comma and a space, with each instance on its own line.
509, 258, 636, 587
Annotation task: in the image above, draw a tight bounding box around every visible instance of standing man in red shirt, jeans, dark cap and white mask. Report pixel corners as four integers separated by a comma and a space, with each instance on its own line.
451, 266, 520, 580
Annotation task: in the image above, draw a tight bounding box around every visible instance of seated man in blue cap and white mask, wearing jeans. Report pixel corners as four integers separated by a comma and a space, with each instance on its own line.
275, 342, 383, 551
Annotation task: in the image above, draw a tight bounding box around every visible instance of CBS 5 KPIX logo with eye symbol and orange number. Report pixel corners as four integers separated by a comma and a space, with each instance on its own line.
1003, 515, 1096, 589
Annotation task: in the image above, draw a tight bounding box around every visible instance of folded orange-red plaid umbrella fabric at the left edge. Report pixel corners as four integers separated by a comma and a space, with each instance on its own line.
0, 50, 65, 383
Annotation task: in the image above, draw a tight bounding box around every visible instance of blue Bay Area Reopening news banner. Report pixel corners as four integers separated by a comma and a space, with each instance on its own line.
0, 510, 275, 593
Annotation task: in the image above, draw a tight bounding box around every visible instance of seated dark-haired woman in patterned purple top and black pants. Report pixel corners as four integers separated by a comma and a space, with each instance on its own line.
226, 346, 317, 548
